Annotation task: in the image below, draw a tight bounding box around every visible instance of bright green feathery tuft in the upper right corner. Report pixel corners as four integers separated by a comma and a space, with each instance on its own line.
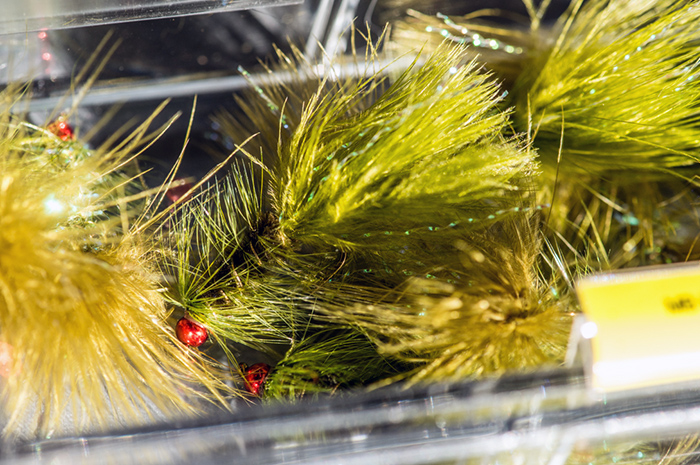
511, 0, 700, 174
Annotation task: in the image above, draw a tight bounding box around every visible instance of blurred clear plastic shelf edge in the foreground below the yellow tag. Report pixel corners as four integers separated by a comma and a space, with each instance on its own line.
6, 369, 700, 465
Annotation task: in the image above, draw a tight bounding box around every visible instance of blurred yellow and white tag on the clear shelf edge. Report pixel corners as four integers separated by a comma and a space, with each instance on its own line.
576, 262, 700, 391
